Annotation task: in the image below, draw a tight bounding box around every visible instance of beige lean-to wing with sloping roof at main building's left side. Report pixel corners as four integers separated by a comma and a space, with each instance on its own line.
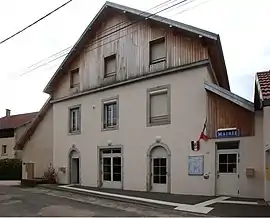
16, 98, 53, 180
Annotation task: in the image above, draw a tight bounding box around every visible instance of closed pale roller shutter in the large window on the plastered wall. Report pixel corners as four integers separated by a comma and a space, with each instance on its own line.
150, 93, 168, 117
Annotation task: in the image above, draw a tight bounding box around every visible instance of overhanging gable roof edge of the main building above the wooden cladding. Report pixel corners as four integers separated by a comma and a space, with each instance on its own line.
44, 1, 230, 94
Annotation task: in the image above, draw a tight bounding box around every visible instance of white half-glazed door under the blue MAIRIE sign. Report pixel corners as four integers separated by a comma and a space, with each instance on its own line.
216, 150, 239, 196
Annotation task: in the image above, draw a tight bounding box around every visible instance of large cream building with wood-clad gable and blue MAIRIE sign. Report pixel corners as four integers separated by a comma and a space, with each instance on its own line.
15, 2, 270, 199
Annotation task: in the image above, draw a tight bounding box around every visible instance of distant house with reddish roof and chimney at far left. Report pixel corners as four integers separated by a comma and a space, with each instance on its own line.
0, 109, 37, 159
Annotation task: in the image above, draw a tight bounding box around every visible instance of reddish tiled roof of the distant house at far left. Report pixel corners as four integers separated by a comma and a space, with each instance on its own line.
0, 112, 38, 129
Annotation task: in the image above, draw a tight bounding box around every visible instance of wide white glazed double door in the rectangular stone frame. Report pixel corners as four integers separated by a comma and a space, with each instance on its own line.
101, 149, 122, 189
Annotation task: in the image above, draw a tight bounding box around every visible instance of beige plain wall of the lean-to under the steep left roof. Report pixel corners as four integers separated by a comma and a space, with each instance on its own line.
22, 108, 53, 178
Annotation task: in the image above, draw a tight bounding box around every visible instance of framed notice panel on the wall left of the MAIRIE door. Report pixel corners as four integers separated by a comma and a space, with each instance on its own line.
188, 155, 204, 176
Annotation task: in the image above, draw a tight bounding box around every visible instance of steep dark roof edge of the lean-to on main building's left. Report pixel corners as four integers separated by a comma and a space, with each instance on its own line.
15, 97, 52, 150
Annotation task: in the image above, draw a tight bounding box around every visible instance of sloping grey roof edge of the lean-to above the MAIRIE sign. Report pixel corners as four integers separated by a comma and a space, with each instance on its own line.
204, 82, 254, 112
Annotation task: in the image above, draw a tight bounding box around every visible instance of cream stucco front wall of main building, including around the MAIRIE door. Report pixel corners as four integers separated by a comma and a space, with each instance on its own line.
53, 67, 264, 198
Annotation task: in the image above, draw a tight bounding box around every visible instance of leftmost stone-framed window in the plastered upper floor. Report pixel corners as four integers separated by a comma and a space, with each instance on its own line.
69, 106, 81, 133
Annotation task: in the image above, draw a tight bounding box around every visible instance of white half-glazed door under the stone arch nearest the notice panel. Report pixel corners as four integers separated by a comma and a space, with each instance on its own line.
151, 157, 168, 192
